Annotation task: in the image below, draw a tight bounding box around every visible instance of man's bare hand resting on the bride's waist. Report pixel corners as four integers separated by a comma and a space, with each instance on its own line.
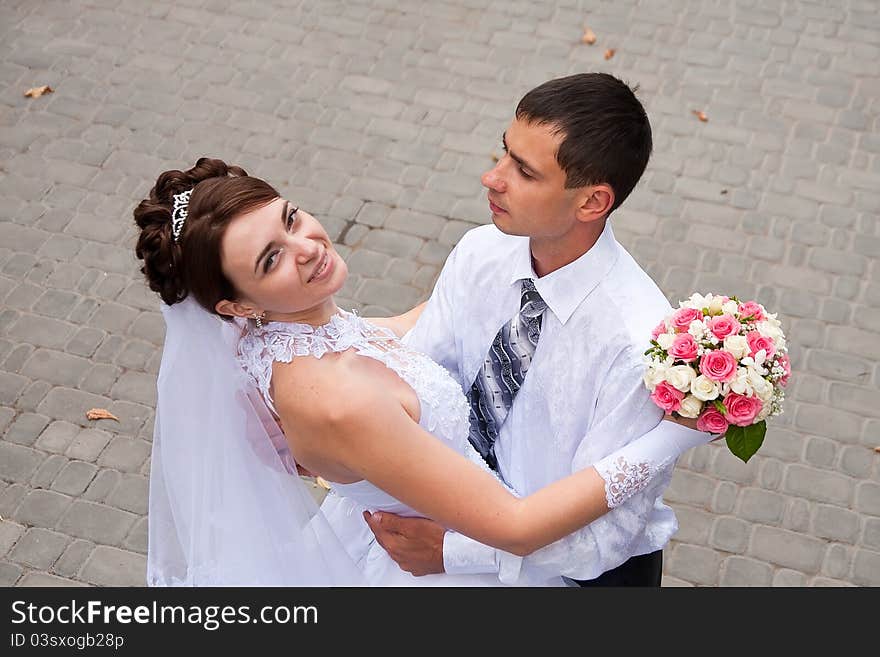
364, 511, 446, 577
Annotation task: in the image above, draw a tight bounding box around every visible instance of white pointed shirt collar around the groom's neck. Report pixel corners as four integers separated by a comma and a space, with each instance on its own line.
510, 220, 620, 324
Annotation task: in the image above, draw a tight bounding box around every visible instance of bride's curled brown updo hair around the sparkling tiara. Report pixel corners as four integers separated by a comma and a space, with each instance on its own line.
134, 157, 279, 319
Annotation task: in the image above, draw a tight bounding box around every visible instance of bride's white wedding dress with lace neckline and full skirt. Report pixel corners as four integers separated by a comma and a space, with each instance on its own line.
238, 311, 562, 586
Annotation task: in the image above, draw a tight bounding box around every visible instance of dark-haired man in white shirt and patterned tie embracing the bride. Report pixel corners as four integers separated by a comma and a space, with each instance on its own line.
365, 73, 692, 586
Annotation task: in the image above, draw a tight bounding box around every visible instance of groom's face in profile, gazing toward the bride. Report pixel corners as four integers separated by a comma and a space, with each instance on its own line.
482, 119, 580, 239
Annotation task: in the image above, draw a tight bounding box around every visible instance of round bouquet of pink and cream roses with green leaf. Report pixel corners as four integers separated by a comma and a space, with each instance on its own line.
645, 294, 791, 461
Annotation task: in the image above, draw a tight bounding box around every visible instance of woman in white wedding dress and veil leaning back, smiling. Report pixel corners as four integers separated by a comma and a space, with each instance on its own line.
134, 158, 713, 586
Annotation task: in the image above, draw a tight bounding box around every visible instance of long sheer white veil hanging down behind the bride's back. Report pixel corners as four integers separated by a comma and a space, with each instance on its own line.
147, 297, 365, 586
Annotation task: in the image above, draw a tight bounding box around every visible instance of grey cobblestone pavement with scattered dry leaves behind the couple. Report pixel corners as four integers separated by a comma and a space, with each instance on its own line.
0, 0, 880, 586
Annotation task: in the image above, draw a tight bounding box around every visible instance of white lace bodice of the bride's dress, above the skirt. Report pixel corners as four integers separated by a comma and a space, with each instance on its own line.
238, 311, 508, 515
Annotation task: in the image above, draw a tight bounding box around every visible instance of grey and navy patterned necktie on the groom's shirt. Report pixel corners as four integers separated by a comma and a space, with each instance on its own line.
468, 278, 547, 470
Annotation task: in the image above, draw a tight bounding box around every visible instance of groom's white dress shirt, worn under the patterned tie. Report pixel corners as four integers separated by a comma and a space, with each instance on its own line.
404, 221, 692, 585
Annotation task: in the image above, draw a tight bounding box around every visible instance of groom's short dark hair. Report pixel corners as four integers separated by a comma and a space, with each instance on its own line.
516, 73, 653, 211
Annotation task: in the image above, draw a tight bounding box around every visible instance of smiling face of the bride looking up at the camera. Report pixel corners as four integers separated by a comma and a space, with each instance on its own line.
220, 198, 348, 319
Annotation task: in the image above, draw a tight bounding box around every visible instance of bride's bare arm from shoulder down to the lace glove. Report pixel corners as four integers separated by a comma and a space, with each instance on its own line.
274, 366, 608, 555
